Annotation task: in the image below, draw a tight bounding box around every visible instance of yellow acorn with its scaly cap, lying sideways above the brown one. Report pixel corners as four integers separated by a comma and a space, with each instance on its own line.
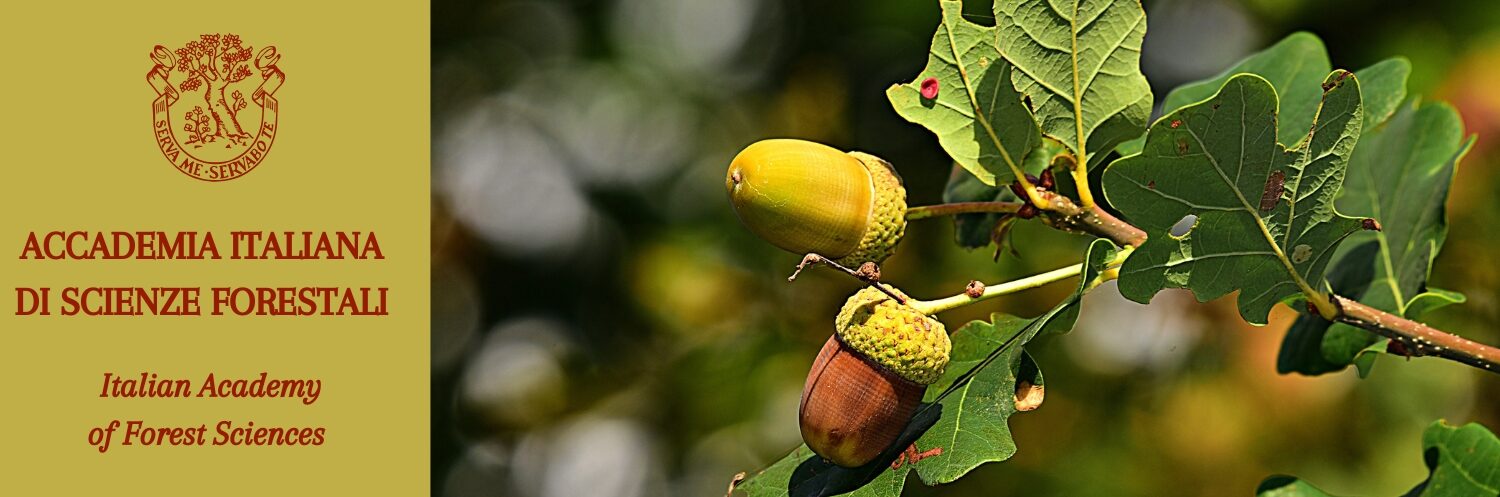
725, 138, 906, 267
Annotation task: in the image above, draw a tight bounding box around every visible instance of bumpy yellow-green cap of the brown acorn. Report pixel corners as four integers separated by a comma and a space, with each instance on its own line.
834, 287, 953, 384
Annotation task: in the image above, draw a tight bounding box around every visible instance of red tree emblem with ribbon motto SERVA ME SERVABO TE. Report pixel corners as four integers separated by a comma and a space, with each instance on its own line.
146, 33, 287, 182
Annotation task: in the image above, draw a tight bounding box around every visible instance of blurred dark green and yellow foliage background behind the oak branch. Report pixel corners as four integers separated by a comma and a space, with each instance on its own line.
432, 0, 1500, 497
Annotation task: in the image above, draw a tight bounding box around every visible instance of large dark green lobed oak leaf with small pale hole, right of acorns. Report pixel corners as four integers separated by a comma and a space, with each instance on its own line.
1104, 71, 1364, 324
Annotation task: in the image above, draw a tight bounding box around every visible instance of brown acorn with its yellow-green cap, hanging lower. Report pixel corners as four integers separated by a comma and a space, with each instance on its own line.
798, 287, 951, 467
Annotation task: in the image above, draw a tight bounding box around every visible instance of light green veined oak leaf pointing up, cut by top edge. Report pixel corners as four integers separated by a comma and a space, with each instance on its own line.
995, 0, 1152, 167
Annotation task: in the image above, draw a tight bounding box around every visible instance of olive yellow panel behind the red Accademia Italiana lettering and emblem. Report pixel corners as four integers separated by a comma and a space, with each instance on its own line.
0, 2, 429, 495
